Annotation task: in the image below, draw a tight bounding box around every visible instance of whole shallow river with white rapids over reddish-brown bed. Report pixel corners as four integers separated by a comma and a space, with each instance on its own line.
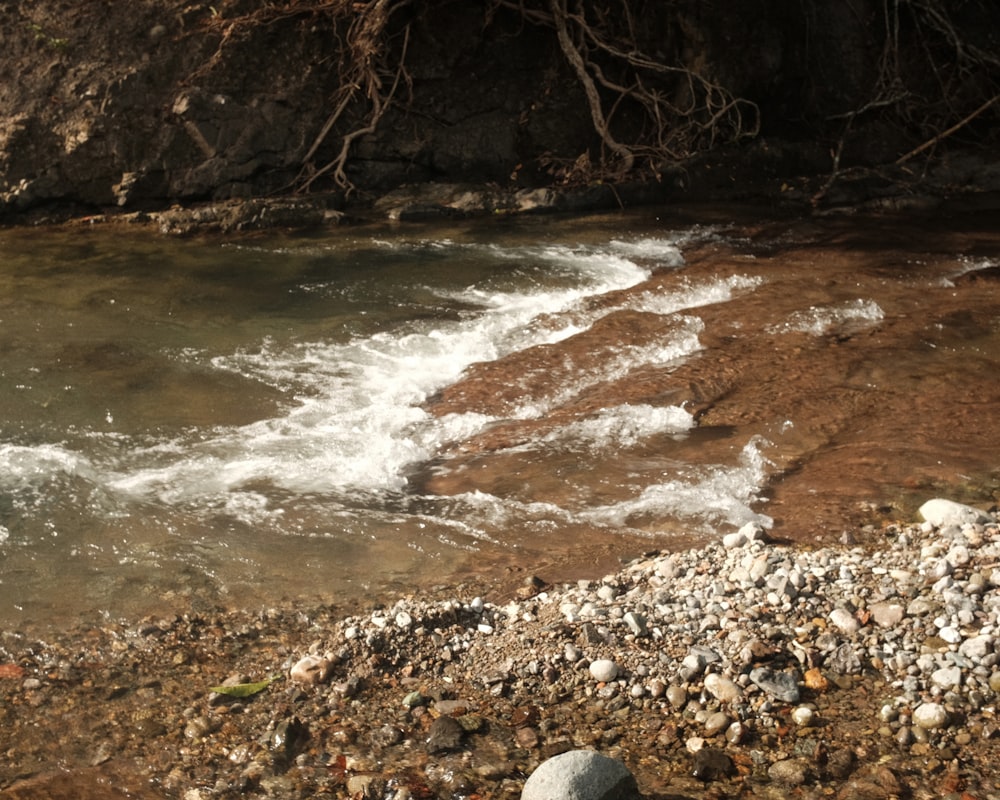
0, 208, 1000, 629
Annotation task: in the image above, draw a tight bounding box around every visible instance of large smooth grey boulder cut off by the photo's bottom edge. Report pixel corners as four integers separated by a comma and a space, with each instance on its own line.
521, 750, 640, 800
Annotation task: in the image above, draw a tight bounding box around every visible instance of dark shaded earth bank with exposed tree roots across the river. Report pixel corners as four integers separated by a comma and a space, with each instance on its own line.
0, 0, 1000, 224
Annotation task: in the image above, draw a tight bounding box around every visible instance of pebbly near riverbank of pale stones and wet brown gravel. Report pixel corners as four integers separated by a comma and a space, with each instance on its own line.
0, 496, 1000, 800
